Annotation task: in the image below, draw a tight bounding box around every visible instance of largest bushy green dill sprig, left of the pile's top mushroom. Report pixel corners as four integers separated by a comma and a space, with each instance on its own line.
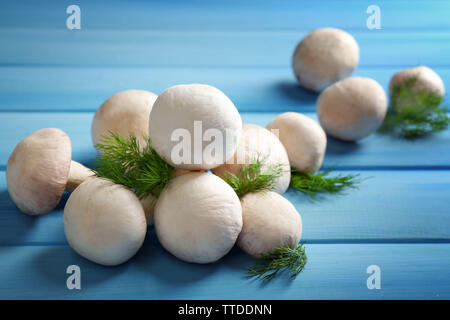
94, 132, 174, 199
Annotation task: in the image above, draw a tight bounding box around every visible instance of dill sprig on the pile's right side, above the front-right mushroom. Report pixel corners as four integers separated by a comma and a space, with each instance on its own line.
223, 157, 283, 198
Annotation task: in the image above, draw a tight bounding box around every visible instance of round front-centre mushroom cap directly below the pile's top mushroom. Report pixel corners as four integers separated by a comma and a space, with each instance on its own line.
154, 172, 242, 263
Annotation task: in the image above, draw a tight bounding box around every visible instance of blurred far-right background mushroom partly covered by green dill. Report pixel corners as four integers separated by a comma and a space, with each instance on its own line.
389, 66, 445, 108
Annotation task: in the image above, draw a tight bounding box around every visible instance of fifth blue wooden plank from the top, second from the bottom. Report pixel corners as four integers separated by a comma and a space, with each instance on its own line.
0, 171, 450, 246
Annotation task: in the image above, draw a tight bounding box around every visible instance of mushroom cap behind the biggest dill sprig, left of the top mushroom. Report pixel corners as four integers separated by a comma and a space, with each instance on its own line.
91, 90, 158, 145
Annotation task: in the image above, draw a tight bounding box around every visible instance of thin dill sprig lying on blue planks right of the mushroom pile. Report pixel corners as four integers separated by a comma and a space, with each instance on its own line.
290, 169, 360, 197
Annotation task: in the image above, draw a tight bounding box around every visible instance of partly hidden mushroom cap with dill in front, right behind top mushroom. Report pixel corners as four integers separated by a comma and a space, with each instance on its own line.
212, 124, 291, 194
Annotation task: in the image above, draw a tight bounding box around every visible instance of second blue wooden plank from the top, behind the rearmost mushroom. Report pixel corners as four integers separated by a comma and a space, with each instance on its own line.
0, 28, 450, 68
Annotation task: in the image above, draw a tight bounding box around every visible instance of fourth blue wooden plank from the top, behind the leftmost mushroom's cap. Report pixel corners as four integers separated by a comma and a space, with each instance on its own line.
0, 112, 450, 170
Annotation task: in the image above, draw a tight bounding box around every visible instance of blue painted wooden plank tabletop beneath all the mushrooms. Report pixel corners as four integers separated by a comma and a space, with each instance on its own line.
0, 0, 450, 299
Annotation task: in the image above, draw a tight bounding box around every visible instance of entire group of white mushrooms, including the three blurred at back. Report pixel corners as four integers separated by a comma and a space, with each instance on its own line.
6, 28, 445, 274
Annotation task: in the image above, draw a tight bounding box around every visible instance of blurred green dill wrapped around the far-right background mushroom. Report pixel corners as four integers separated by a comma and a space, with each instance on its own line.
379, 76, 450, 140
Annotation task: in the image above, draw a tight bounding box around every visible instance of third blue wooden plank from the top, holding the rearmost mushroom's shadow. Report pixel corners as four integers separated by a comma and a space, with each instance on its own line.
0, 66, 450, 113
